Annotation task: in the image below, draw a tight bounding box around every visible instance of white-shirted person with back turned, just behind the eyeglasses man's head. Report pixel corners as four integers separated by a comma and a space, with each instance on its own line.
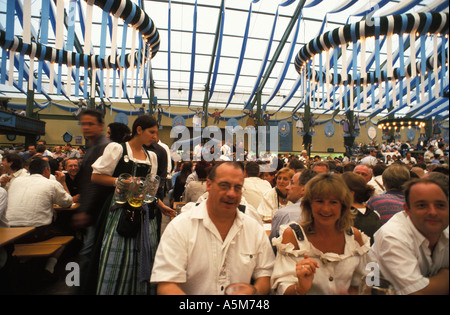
242, 161, 272, 209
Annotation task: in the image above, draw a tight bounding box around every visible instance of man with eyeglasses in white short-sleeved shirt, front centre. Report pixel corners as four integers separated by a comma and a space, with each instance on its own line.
150, 162, 274, 295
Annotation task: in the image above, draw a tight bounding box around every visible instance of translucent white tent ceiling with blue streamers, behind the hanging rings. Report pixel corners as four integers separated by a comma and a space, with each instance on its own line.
0, 0, 448, 117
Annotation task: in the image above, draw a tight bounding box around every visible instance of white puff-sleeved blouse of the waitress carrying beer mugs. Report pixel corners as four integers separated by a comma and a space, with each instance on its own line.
92, 142, 158, 176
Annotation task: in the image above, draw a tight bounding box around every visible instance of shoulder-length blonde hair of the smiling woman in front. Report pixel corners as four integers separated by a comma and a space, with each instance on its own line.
300, 173, 354, 233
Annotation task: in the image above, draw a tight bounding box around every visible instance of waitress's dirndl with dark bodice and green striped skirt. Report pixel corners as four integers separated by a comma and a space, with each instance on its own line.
96, 144, 158, 295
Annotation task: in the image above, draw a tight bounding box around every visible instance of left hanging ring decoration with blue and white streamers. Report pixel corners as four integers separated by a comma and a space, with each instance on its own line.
0, 0, 160, 98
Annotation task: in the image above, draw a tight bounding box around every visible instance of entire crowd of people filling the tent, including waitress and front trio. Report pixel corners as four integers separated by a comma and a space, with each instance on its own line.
0, 110, 449, 295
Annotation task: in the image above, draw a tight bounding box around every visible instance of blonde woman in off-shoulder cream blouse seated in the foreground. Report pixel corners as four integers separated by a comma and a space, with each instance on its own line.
271, 173, 370, 295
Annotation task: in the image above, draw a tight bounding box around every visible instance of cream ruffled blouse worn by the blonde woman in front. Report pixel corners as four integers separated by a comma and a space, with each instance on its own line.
271, 222, 370, 295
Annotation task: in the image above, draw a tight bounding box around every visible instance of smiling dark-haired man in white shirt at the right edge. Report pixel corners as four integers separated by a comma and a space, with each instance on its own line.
371, 178, 449, 295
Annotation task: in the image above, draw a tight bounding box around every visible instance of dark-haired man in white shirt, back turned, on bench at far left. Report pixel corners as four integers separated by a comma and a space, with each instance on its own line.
6, 158, 72, 282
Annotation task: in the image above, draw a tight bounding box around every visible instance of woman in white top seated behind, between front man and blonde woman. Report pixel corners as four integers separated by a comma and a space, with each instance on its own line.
257, 167, 295, 223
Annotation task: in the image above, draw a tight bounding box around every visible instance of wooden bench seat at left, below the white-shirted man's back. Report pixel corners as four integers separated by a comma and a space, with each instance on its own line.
12, 236, 74, 259
